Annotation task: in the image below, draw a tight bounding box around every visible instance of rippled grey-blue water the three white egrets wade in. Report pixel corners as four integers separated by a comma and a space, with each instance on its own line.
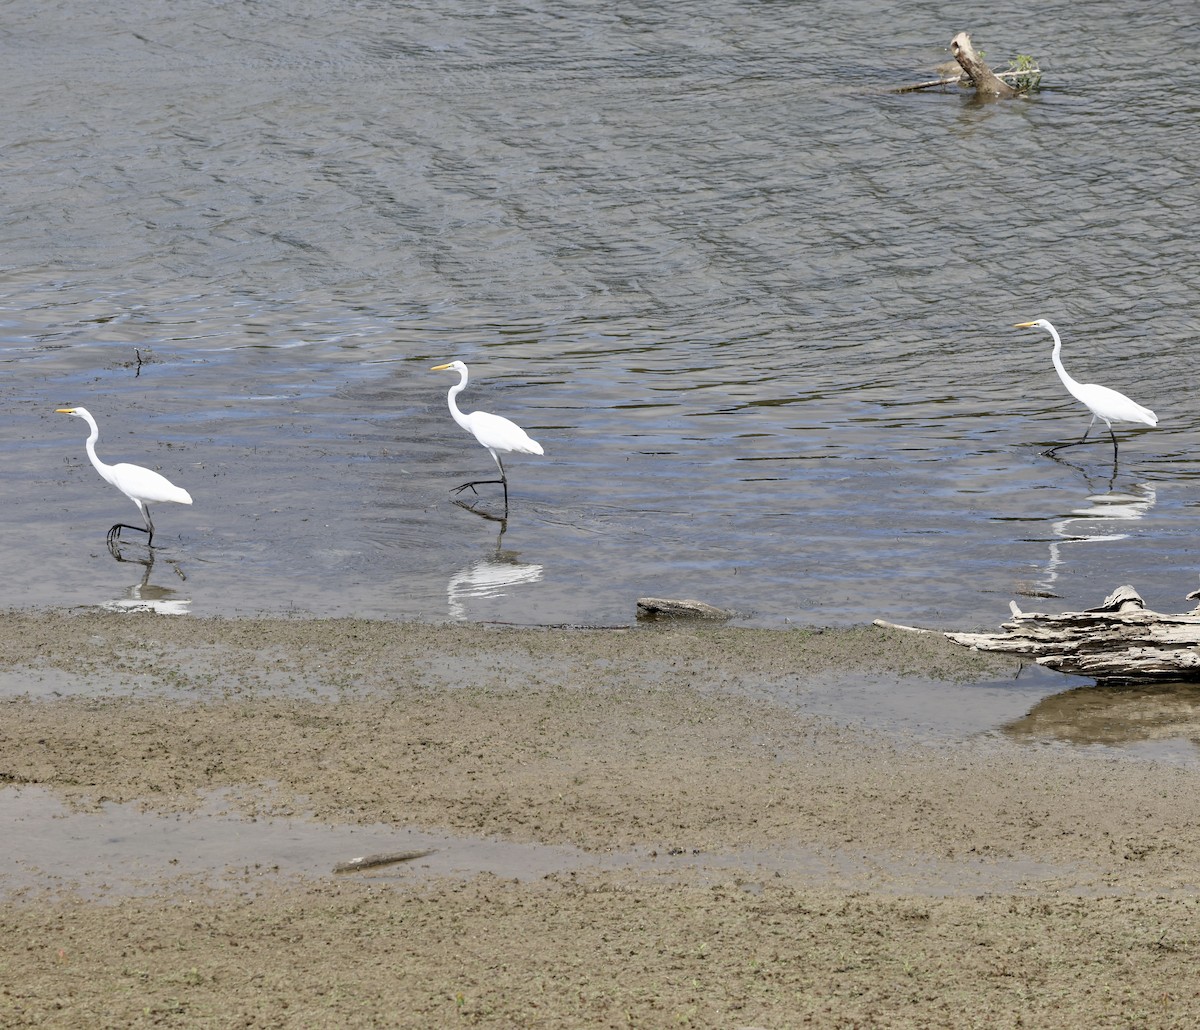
0, 0, 1200, 628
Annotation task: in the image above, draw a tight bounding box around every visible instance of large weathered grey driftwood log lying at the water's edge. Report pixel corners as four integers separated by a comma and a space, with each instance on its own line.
878, 586, 1200, 683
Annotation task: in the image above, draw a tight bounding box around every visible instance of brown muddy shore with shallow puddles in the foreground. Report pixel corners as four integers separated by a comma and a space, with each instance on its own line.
0, 612, 1200, 1028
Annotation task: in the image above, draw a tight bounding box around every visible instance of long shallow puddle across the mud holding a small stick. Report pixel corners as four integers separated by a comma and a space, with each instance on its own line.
0, 786, 1074, 902
